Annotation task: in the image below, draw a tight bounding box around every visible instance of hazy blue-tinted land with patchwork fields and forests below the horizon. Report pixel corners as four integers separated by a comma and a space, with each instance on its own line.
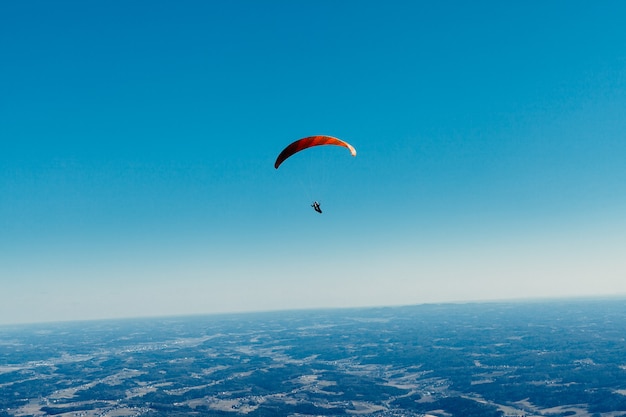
0, 299, 626, 417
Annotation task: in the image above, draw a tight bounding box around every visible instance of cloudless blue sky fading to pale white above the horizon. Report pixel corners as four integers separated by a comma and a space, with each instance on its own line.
0, 0, 626, 324
